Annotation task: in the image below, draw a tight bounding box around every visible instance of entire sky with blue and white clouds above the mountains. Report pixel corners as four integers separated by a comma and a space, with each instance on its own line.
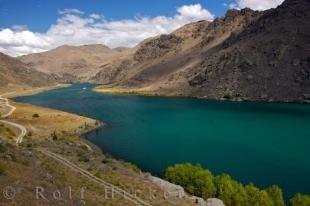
0, 0, 283, 56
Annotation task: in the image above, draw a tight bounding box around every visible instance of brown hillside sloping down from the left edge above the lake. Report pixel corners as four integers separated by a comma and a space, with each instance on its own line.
0, 53, 55, 88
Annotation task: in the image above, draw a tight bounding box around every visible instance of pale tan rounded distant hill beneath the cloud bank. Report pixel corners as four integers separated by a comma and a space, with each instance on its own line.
20, 45, 119, 81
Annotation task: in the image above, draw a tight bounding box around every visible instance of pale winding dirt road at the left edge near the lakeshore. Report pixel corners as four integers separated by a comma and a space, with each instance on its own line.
0, 95, 27, 145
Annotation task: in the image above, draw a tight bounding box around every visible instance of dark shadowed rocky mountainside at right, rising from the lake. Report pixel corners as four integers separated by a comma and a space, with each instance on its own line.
189, 0, 310, 101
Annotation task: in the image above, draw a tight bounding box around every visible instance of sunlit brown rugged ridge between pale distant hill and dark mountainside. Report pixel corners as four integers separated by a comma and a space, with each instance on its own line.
93, 10, 260, 86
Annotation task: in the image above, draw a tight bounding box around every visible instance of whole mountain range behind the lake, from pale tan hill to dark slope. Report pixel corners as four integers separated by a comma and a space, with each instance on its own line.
1, 0, 310, 101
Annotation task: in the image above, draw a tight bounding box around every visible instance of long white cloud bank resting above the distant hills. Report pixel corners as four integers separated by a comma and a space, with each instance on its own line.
0, 4, 214, 56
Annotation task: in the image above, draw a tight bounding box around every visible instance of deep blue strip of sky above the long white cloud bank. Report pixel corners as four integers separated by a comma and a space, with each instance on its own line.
0, 0, 229, 32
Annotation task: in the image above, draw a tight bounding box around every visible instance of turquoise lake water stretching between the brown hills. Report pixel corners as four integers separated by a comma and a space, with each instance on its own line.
15, 84, 310, 196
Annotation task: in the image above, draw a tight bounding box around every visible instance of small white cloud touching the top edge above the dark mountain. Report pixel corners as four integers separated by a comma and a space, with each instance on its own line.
229, 0, 284, 11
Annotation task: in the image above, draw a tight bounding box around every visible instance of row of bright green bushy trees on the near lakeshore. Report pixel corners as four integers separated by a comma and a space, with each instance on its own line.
165, 163, 310, 206
